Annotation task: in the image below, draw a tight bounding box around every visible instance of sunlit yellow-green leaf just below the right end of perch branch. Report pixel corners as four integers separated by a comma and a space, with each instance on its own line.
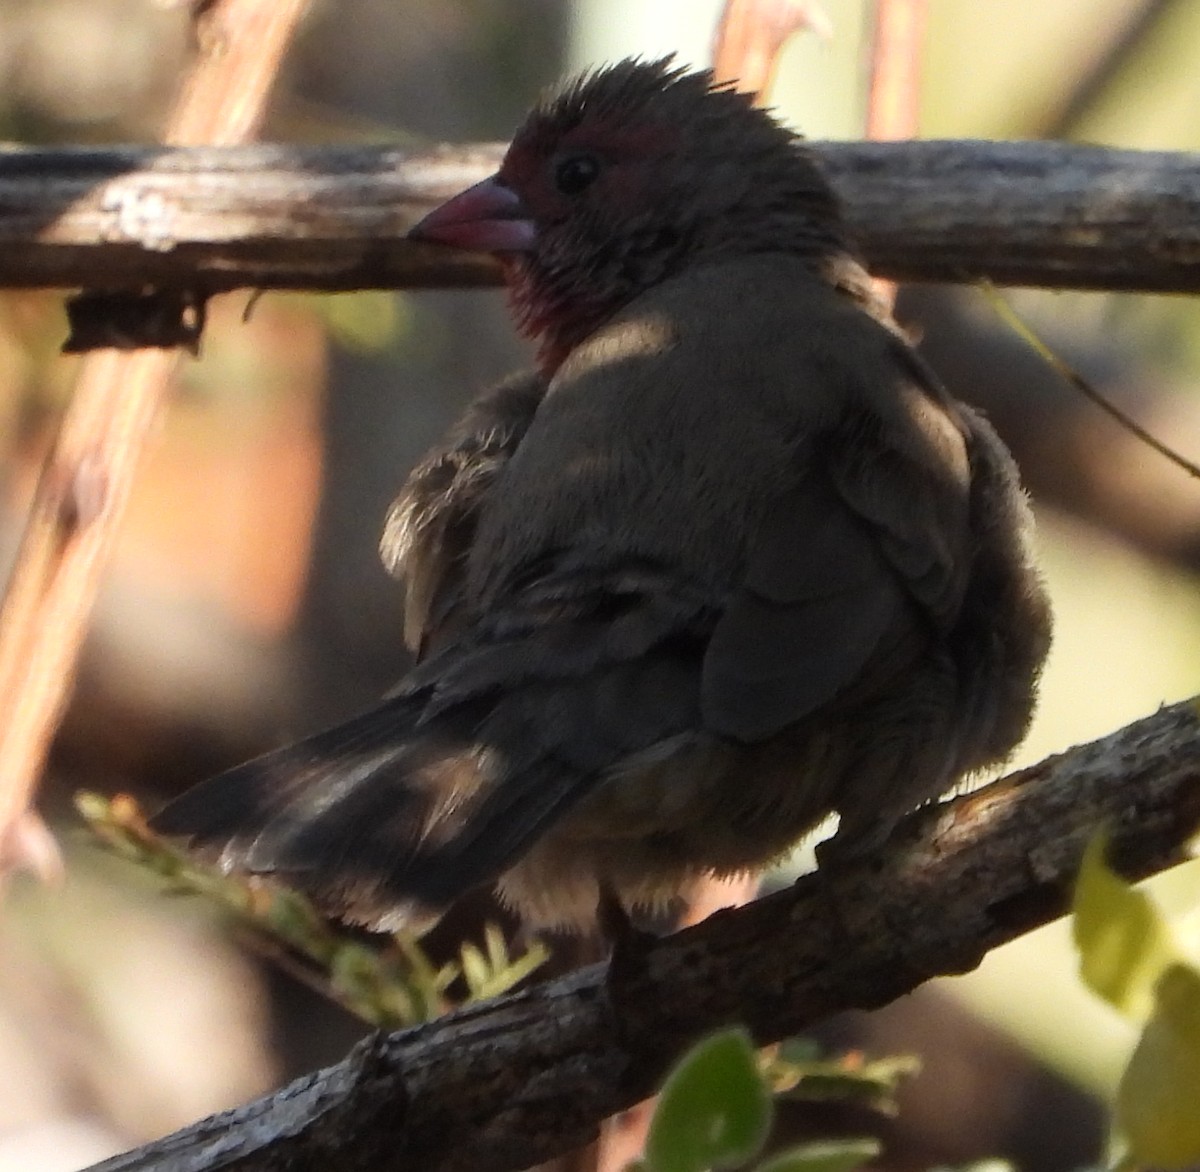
1072, 833, 1180, 1021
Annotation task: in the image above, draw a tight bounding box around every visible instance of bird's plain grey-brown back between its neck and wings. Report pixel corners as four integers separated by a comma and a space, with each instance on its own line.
470, 253, 931, 612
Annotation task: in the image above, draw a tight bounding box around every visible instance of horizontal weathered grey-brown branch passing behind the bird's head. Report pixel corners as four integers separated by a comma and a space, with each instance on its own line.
0, 142, 1200, 292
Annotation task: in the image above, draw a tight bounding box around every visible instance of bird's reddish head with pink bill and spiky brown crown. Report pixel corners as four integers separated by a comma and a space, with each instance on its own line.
410, 58, 845, 371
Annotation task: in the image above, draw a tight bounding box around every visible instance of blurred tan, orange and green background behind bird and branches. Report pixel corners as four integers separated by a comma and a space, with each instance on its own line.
0, 0, 1200, 1172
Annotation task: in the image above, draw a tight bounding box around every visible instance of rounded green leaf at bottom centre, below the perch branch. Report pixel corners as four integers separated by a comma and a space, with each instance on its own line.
646, 1029, 773, 1172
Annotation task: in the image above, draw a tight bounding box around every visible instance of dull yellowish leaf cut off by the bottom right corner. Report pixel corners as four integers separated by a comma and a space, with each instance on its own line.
1116, 964, 1200, 1168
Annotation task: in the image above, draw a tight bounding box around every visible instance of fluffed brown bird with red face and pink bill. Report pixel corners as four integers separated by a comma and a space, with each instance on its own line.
151, 58, 1051, 933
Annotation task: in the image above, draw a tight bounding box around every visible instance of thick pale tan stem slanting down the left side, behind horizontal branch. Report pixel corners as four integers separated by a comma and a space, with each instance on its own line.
0, 0, 306, 873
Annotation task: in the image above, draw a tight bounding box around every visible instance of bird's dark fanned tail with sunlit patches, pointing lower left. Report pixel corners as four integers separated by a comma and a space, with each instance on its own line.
150, 696, 589, 930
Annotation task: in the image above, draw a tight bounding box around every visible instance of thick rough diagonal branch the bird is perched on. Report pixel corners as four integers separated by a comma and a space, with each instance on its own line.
82, 701, 1200, 1172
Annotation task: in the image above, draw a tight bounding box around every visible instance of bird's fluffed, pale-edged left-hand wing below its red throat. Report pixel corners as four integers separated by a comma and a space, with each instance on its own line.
379, 372, 546, 656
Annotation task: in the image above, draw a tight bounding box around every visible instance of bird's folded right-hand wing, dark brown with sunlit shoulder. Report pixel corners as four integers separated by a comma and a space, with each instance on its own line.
702, 341, 970, 741
